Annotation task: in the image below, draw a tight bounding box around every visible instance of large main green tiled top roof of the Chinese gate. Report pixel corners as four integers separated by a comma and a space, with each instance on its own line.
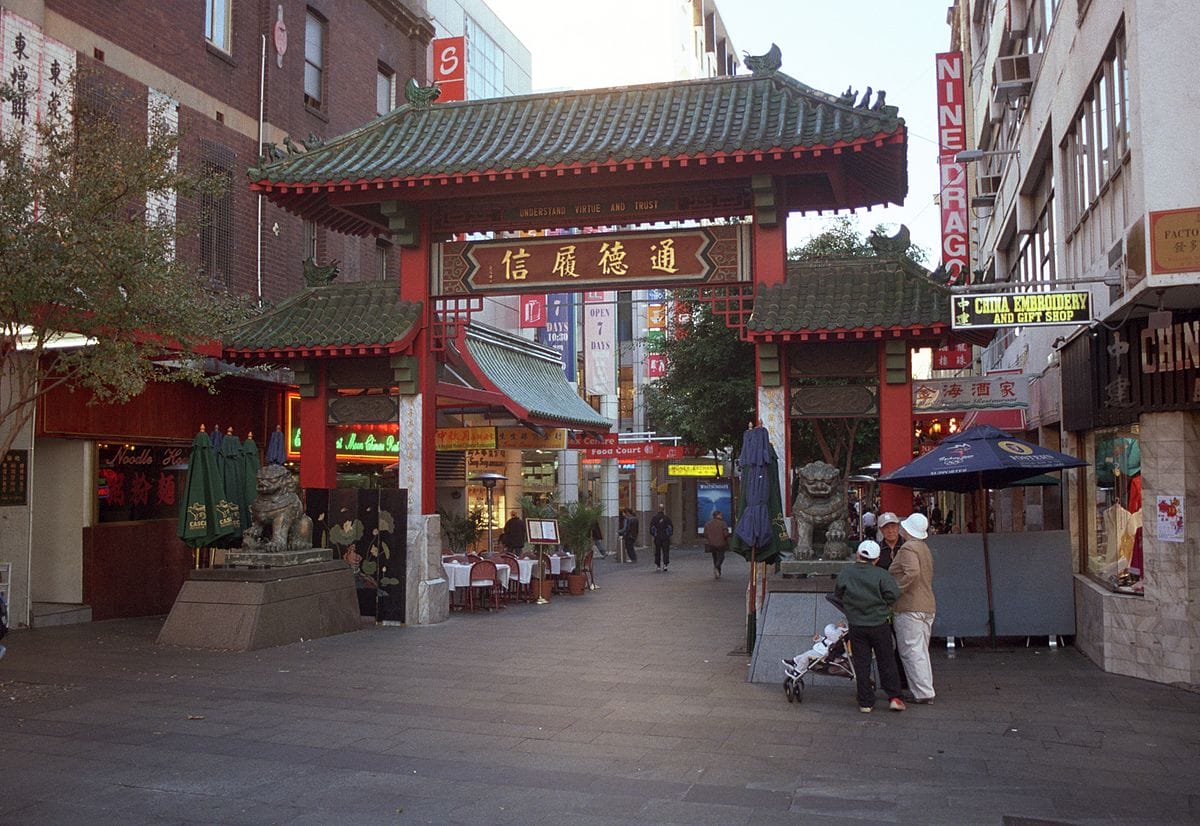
250, 73, 907, 233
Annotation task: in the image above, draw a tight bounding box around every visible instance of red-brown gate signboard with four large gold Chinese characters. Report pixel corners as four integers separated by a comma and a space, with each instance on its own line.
433, 226, 750, 295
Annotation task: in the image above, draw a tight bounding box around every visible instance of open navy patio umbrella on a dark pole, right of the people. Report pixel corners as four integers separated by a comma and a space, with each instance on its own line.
880, 425, 1087, 646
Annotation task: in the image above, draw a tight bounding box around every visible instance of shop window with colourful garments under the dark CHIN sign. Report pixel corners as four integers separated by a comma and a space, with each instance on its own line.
1087, 425, 1142, 593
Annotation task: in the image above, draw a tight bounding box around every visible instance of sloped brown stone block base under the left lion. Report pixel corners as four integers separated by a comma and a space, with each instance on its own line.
158, 559, 361, 651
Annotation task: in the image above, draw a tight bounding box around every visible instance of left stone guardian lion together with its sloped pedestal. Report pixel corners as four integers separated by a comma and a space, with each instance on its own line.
158, 465, 362, 651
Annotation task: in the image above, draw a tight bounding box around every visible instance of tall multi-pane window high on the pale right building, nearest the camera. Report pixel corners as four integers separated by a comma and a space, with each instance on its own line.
1061, 30, 1129, 228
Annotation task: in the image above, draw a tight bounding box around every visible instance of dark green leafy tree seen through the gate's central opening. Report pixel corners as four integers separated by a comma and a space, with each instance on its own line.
646, 304, 755, 475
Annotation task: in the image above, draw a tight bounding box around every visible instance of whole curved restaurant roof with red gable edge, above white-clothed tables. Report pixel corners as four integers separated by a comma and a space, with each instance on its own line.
438, 323, 612, 432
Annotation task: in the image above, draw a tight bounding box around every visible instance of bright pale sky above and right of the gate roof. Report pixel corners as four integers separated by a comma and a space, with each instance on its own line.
486, 0, 950, 262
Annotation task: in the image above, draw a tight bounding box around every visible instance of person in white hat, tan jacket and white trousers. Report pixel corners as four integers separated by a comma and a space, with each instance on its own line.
890, 513, 937, 704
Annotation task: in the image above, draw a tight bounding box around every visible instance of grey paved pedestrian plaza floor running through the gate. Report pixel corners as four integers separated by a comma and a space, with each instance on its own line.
0, 549, 1200, 826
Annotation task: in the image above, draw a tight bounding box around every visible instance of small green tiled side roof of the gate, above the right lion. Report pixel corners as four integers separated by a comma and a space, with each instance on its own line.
746, 256, 950, 341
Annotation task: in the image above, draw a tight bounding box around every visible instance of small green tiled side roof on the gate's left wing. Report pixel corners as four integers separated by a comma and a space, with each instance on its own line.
223, 281, 421, 361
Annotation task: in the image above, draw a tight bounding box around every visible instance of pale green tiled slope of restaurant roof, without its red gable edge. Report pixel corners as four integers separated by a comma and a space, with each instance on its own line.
464, 324, 612, 430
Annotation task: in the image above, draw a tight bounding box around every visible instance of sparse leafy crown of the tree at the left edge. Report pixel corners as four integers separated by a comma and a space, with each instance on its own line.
0, 78, 245, 456
